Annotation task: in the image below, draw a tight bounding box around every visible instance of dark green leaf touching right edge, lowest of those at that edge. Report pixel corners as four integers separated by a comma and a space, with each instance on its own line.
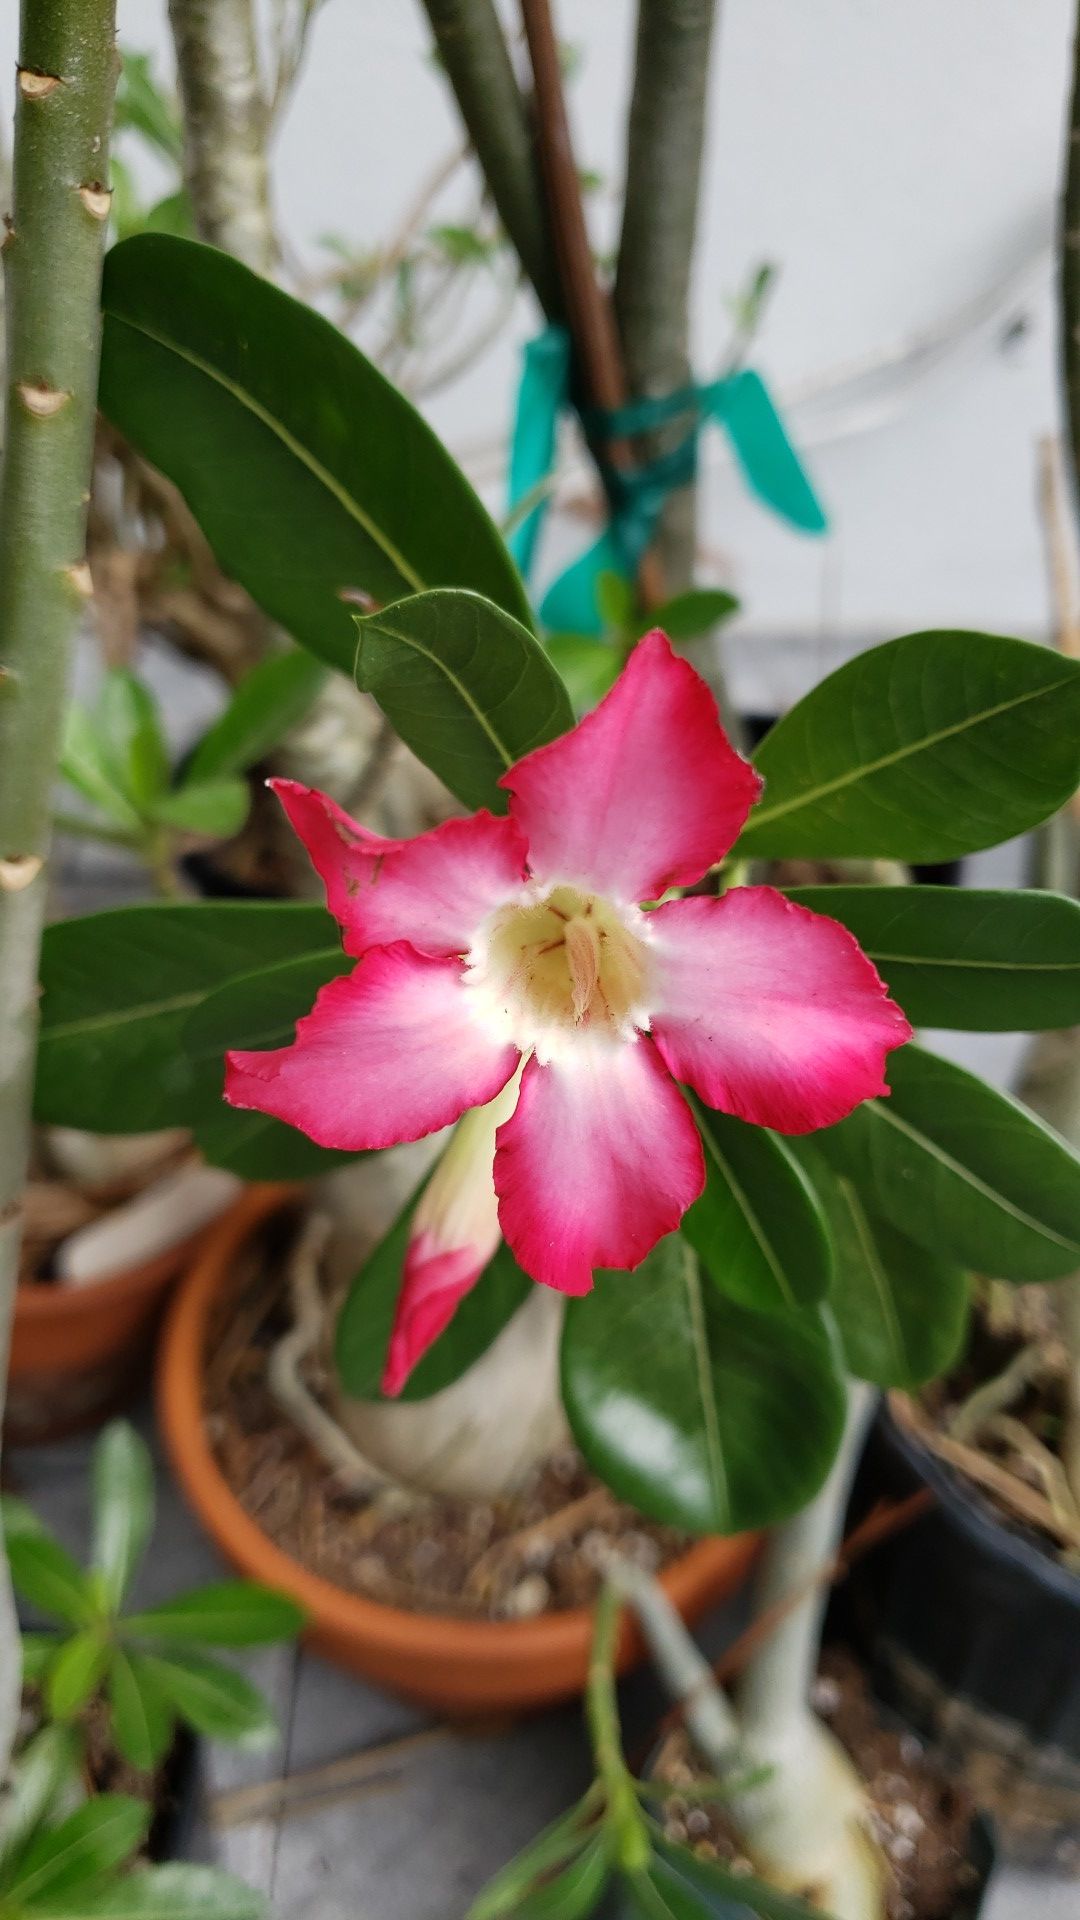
815, 1046, 1080, 1281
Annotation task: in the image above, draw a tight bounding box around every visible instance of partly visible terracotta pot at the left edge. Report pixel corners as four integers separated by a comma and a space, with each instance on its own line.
4, 1231, 202, 1446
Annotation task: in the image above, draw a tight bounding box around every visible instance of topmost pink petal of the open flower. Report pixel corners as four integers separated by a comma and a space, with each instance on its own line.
500, 630, 761, 902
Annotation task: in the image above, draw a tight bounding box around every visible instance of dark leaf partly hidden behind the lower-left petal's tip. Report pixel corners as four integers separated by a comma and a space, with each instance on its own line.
183, 948, 356, 1181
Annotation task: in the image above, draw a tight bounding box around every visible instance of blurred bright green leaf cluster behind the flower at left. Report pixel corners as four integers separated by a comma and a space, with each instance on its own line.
56, 649, 325, 893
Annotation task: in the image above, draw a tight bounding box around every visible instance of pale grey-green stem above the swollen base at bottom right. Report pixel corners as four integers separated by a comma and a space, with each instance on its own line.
736, 1382, 874, 1751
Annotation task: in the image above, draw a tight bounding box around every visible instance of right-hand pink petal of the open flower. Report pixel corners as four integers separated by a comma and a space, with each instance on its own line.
650, 887, 911, 1133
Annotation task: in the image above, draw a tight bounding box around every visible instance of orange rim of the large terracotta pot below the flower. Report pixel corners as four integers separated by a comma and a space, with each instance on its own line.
158, 1185, 753, 1663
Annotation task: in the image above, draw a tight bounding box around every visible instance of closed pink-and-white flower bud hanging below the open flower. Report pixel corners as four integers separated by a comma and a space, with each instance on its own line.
382, 1075, 517, 1394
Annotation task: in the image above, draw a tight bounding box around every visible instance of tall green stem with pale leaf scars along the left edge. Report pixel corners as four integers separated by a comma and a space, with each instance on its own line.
0, 0, 115, 1780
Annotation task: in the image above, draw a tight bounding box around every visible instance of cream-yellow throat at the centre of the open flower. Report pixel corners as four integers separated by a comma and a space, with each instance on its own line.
465, 887, 651, 1064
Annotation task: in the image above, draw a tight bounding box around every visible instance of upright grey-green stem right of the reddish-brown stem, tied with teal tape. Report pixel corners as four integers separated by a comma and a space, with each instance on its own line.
615, 0, 717, 593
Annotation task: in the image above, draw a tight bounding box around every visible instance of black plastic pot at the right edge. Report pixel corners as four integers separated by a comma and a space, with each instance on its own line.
838, 1407, 1080, 1872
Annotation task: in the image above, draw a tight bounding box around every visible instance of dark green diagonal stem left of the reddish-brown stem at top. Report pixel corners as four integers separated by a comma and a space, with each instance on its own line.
423, 0, 561, 319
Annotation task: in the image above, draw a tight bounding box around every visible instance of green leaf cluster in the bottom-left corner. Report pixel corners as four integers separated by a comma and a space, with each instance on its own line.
0, 1726, 265, 1920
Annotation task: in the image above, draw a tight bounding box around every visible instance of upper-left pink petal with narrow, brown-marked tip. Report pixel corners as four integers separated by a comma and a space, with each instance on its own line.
271, 780, 525, 958
